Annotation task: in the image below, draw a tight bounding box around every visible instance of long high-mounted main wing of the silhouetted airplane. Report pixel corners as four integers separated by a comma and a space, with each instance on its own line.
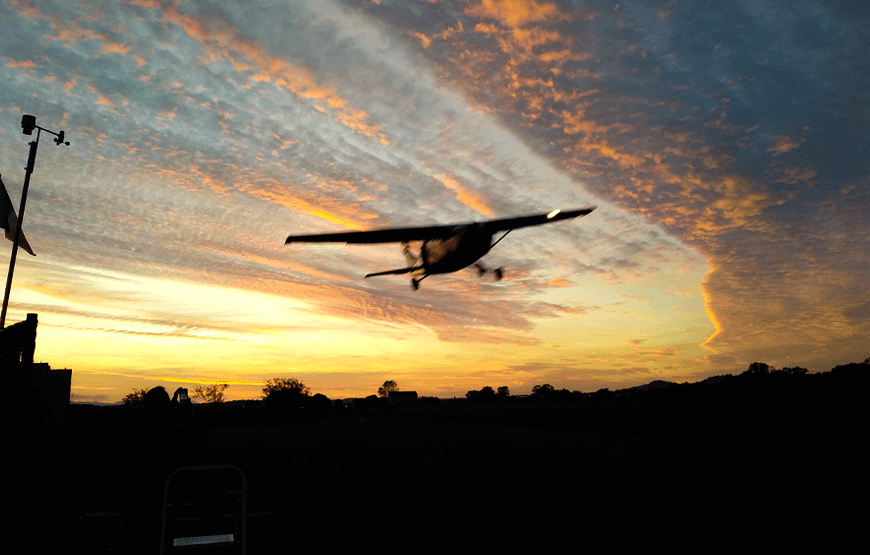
284, 206, 595, 245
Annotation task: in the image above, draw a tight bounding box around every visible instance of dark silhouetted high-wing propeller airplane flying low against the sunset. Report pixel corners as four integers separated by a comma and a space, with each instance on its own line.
284, 206, 595, 291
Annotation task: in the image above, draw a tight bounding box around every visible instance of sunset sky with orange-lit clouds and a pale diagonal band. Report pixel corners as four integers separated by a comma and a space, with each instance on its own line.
0, 0, 870, 402
